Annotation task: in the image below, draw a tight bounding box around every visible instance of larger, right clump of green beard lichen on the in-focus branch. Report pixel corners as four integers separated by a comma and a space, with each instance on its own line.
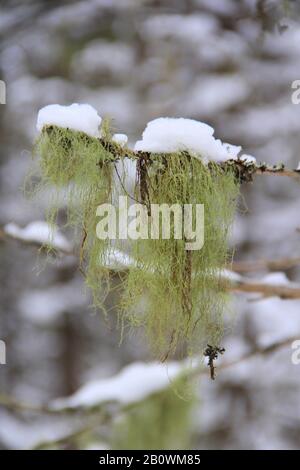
123, 152, 239, 360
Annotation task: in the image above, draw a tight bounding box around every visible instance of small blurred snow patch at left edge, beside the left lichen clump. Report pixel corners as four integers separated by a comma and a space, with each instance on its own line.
4, 220, 72, 252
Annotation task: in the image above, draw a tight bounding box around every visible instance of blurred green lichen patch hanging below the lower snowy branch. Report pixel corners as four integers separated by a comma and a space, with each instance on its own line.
111, 381, 194, 450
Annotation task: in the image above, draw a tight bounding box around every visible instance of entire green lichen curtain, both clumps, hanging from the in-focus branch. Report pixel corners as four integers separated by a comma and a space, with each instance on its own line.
29, 126, 239, 360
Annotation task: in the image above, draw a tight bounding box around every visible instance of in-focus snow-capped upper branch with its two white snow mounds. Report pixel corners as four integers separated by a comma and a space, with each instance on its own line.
37, 103, 300, 182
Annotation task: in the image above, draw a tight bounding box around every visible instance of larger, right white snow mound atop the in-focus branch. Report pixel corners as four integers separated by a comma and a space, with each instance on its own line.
134, 118, 241, 162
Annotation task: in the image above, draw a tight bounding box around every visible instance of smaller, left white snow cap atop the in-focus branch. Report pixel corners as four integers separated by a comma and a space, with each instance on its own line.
36, 103, 102, 137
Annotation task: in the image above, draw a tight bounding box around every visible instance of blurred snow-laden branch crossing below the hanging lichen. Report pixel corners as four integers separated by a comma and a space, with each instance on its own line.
0, 336, 299, 416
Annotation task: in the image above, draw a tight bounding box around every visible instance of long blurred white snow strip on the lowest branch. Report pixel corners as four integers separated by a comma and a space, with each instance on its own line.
53, 362, 184, 409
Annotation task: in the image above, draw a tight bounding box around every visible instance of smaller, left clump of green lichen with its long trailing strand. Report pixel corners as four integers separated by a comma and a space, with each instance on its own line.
34, 126, 115, 298
